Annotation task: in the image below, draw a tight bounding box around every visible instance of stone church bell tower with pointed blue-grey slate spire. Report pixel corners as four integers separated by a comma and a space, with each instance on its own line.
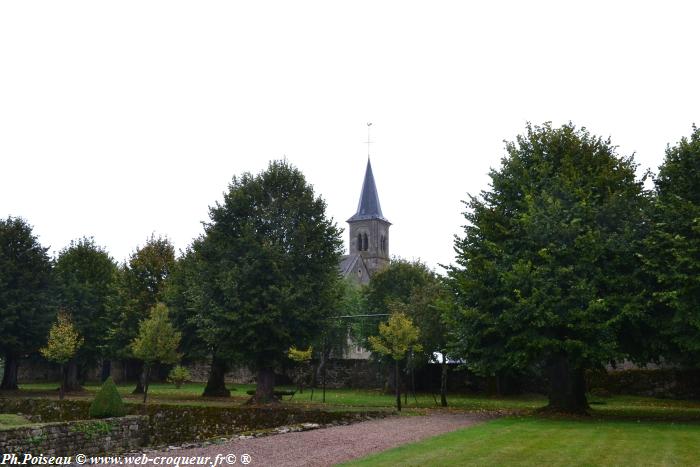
340, 158, 391, 285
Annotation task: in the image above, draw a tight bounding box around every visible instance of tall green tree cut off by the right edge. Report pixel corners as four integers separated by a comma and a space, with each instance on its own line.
643, 126, 700, 367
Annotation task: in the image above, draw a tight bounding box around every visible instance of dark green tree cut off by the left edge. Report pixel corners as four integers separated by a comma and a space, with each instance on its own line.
0, 217, 55, 390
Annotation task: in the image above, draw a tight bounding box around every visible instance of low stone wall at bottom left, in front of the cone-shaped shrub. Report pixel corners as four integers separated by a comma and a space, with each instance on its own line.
0, 415, 148, 456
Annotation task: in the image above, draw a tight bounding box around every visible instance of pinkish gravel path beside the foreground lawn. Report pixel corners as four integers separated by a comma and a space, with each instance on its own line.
139, 413, 485, 467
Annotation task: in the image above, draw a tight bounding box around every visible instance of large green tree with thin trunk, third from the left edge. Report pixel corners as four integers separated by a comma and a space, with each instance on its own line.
107, 235, 175, 393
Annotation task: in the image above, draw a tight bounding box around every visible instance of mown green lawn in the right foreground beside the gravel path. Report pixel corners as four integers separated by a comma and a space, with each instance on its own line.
345, 417, 700, 466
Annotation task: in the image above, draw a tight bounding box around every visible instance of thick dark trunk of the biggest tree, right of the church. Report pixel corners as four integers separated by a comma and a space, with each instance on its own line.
547, 354, 588, 414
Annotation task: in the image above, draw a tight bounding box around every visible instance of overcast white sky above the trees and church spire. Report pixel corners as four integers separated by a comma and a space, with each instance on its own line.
0, 0, 700, 266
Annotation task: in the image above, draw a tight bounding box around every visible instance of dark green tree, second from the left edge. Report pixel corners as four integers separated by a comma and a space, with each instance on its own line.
54, 238, 116, 391
